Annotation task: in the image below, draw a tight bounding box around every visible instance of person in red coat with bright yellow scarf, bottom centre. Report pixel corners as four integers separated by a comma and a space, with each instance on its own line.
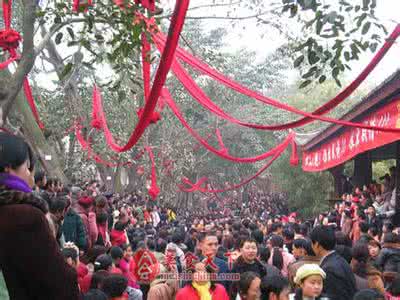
175, 262, 229, 300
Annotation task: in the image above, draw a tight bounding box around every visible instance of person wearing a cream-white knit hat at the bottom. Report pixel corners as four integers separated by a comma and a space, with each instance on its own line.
294, 264, 326, 300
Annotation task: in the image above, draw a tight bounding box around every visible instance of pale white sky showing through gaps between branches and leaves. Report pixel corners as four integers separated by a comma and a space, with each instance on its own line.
161, 0, 400, 88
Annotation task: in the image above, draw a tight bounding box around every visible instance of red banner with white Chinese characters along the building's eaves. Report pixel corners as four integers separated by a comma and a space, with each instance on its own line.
302, 99, 400, 172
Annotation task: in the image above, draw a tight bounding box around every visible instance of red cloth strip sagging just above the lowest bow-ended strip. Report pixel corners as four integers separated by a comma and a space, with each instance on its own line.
162, 88, 292, 163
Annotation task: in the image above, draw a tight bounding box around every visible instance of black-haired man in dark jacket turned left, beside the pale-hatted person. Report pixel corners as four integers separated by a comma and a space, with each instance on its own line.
310, 226, 356, 300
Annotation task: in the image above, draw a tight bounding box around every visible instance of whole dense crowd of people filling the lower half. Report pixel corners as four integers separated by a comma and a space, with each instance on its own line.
0, 132, 400, 300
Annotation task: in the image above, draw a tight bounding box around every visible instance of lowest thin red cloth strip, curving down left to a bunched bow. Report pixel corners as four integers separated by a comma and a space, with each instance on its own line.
178, 133, 295, 194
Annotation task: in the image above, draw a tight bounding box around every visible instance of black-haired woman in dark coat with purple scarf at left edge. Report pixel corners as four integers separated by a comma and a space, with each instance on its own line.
0, 132, 79, 300
